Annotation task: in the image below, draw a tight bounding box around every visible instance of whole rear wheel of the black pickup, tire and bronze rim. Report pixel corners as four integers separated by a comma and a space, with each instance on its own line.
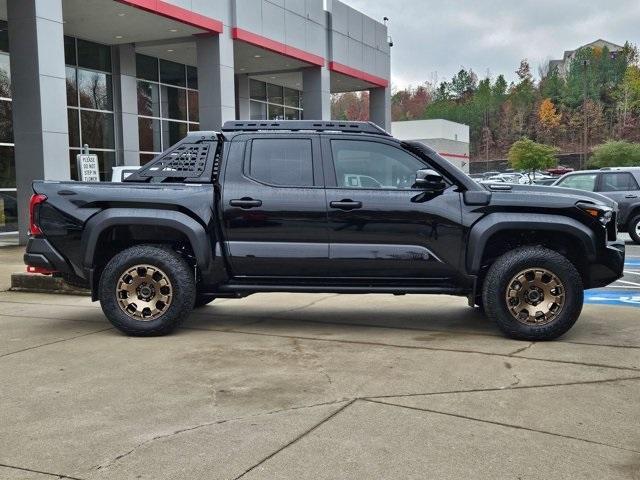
98, 245, 196, 336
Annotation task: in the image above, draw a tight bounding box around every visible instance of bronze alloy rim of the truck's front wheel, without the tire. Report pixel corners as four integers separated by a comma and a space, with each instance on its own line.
505, 268, 565, 325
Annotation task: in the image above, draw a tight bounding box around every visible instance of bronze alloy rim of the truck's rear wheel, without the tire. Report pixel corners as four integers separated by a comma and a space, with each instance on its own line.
116, 265, 173, 322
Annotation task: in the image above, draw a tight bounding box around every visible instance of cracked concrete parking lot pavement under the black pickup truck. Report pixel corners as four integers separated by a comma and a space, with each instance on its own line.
0, 242, 640, 480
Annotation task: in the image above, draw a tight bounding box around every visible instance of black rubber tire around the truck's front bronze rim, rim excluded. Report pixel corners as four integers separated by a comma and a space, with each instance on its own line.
482, 247, 584, 341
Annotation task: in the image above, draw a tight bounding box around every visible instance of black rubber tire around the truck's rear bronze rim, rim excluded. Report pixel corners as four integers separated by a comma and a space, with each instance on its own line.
98, 245, 196, 337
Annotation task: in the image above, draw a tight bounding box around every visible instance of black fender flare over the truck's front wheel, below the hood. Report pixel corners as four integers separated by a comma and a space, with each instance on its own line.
465, 213, 597, 275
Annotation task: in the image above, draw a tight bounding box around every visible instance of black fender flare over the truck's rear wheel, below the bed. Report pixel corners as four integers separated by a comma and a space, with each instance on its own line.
81, 208, 213, 274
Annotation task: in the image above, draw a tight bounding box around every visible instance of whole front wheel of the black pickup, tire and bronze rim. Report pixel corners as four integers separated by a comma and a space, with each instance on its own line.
482, 247, 584, 341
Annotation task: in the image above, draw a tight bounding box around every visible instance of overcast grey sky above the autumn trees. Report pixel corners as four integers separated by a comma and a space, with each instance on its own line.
344, 0, 640, 87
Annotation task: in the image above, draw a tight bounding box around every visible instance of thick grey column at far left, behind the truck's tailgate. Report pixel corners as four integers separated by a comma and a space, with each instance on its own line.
7, 0, 70, 243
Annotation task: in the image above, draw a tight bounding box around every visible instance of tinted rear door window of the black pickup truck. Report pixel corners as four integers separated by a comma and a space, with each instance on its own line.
249, 138, 313, 187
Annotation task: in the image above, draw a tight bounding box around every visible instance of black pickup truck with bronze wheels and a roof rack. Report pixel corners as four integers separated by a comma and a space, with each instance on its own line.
24, 121, 624, 340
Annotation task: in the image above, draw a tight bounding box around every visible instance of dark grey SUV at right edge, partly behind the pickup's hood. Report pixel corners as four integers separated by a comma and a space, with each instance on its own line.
553, 167, 640, 243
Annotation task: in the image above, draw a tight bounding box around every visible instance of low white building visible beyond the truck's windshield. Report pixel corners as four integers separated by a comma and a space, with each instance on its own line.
391, 119, 469, 173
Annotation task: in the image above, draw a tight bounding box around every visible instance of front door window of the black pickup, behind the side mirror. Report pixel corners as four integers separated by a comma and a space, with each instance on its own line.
331, 140, 426, 189
